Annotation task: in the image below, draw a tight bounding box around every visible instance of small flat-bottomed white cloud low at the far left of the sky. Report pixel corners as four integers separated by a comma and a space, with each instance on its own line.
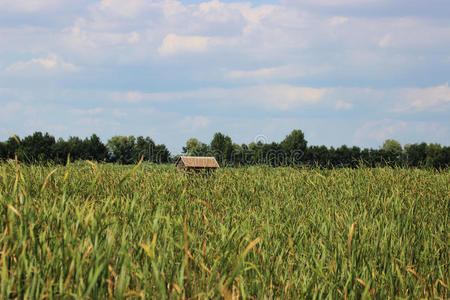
6, 54, 80, 72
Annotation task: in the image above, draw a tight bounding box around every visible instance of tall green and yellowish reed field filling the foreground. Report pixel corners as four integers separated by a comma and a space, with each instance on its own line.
0, 161, 450, 299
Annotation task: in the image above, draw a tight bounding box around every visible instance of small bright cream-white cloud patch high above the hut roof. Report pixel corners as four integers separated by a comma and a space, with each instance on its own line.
158, 34, 211, 55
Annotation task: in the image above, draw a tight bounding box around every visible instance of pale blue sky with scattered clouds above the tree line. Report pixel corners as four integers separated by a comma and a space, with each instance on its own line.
0, 0, 450, 154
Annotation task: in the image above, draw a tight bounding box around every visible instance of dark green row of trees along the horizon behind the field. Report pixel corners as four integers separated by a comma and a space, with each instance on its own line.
0, 130, 450, 169
